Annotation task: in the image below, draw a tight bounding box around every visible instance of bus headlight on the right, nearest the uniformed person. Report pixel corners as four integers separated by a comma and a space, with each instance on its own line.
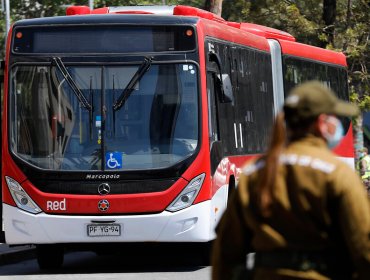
166, 173, 206, 212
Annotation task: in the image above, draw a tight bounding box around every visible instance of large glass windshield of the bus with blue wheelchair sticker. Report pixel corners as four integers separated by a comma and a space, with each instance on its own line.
10, 63, 199, 171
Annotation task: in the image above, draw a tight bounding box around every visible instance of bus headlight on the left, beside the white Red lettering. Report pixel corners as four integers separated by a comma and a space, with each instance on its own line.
5, 176, 41, 214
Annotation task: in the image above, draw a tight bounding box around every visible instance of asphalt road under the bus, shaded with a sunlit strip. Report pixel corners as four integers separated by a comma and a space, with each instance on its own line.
0, 248, 211, 280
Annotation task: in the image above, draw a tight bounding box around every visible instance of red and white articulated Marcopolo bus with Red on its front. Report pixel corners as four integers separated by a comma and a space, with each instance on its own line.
2, 6, 354, 268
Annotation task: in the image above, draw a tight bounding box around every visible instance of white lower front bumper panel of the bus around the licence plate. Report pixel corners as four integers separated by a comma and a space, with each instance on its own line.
3, 185, 227, 244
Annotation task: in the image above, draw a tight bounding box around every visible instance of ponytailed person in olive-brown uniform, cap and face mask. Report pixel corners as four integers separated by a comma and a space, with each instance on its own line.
211, 81, 370, 280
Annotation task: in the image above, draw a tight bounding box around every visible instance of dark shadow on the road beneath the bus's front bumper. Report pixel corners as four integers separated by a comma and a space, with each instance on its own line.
0, 243, 209, 279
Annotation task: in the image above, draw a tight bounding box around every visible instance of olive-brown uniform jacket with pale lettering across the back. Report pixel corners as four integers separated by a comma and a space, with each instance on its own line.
212, 136, 370, 280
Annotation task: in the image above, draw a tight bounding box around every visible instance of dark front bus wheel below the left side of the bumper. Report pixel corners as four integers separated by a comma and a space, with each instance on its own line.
36, 244, 64, 269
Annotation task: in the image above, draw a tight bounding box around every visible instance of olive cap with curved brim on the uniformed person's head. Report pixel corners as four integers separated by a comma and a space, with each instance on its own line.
284, 81, 360, 119
